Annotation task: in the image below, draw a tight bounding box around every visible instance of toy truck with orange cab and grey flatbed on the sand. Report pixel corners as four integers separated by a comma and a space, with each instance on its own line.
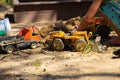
0, 27, 40, 53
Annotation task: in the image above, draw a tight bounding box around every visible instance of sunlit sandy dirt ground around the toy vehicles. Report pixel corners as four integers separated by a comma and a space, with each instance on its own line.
0, 6, 120, 80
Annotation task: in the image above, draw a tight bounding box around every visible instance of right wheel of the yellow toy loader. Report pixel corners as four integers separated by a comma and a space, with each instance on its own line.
75, 39, 87, 51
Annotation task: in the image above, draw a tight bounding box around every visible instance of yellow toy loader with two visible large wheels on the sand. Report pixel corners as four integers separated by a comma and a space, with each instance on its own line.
47, 31, 92, 51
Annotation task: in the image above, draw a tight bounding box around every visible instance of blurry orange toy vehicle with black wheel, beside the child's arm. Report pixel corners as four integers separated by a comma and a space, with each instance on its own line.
88, 17, 110, 38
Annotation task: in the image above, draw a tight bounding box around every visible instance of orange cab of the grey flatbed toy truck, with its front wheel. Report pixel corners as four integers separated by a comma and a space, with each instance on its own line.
19, 26, 40, 49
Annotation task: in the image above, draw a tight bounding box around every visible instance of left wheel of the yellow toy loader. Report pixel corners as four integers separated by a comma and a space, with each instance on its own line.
53, 39, 64, 51
